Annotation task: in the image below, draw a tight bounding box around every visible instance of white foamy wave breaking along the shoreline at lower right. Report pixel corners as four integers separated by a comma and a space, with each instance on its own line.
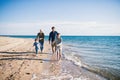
64, 52, 120, 80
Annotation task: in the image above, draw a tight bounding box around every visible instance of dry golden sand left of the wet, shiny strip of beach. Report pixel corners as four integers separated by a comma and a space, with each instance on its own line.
0, 37, 50, 80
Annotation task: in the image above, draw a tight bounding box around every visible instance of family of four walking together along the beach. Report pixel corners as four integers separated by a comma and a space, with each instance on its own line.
33, 26, 62, 60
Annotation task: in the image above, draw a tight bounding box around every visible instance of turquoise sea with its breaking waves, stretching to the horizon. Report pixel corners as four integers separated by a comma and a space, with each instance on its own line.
2, 36, 120, 80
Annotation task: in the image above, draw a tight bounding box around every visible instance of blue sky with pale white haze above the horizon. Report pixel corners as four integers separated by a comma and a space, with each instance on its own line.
0, 0, 120, 35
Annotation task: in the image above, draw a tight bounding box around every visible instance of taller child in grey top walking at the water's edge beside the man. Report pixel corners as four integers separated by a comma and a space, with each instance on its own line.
55, 33, 62, 60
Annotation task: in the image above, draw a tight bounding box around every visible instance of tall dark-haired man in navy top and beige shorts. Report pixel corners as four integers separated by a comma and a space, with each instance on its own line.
49, 26, 58, 53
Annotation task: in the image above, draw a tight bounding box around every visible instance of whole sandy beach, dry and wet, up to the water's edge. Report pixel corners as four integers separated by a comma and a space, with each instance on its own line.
0, 37, 107, 80
